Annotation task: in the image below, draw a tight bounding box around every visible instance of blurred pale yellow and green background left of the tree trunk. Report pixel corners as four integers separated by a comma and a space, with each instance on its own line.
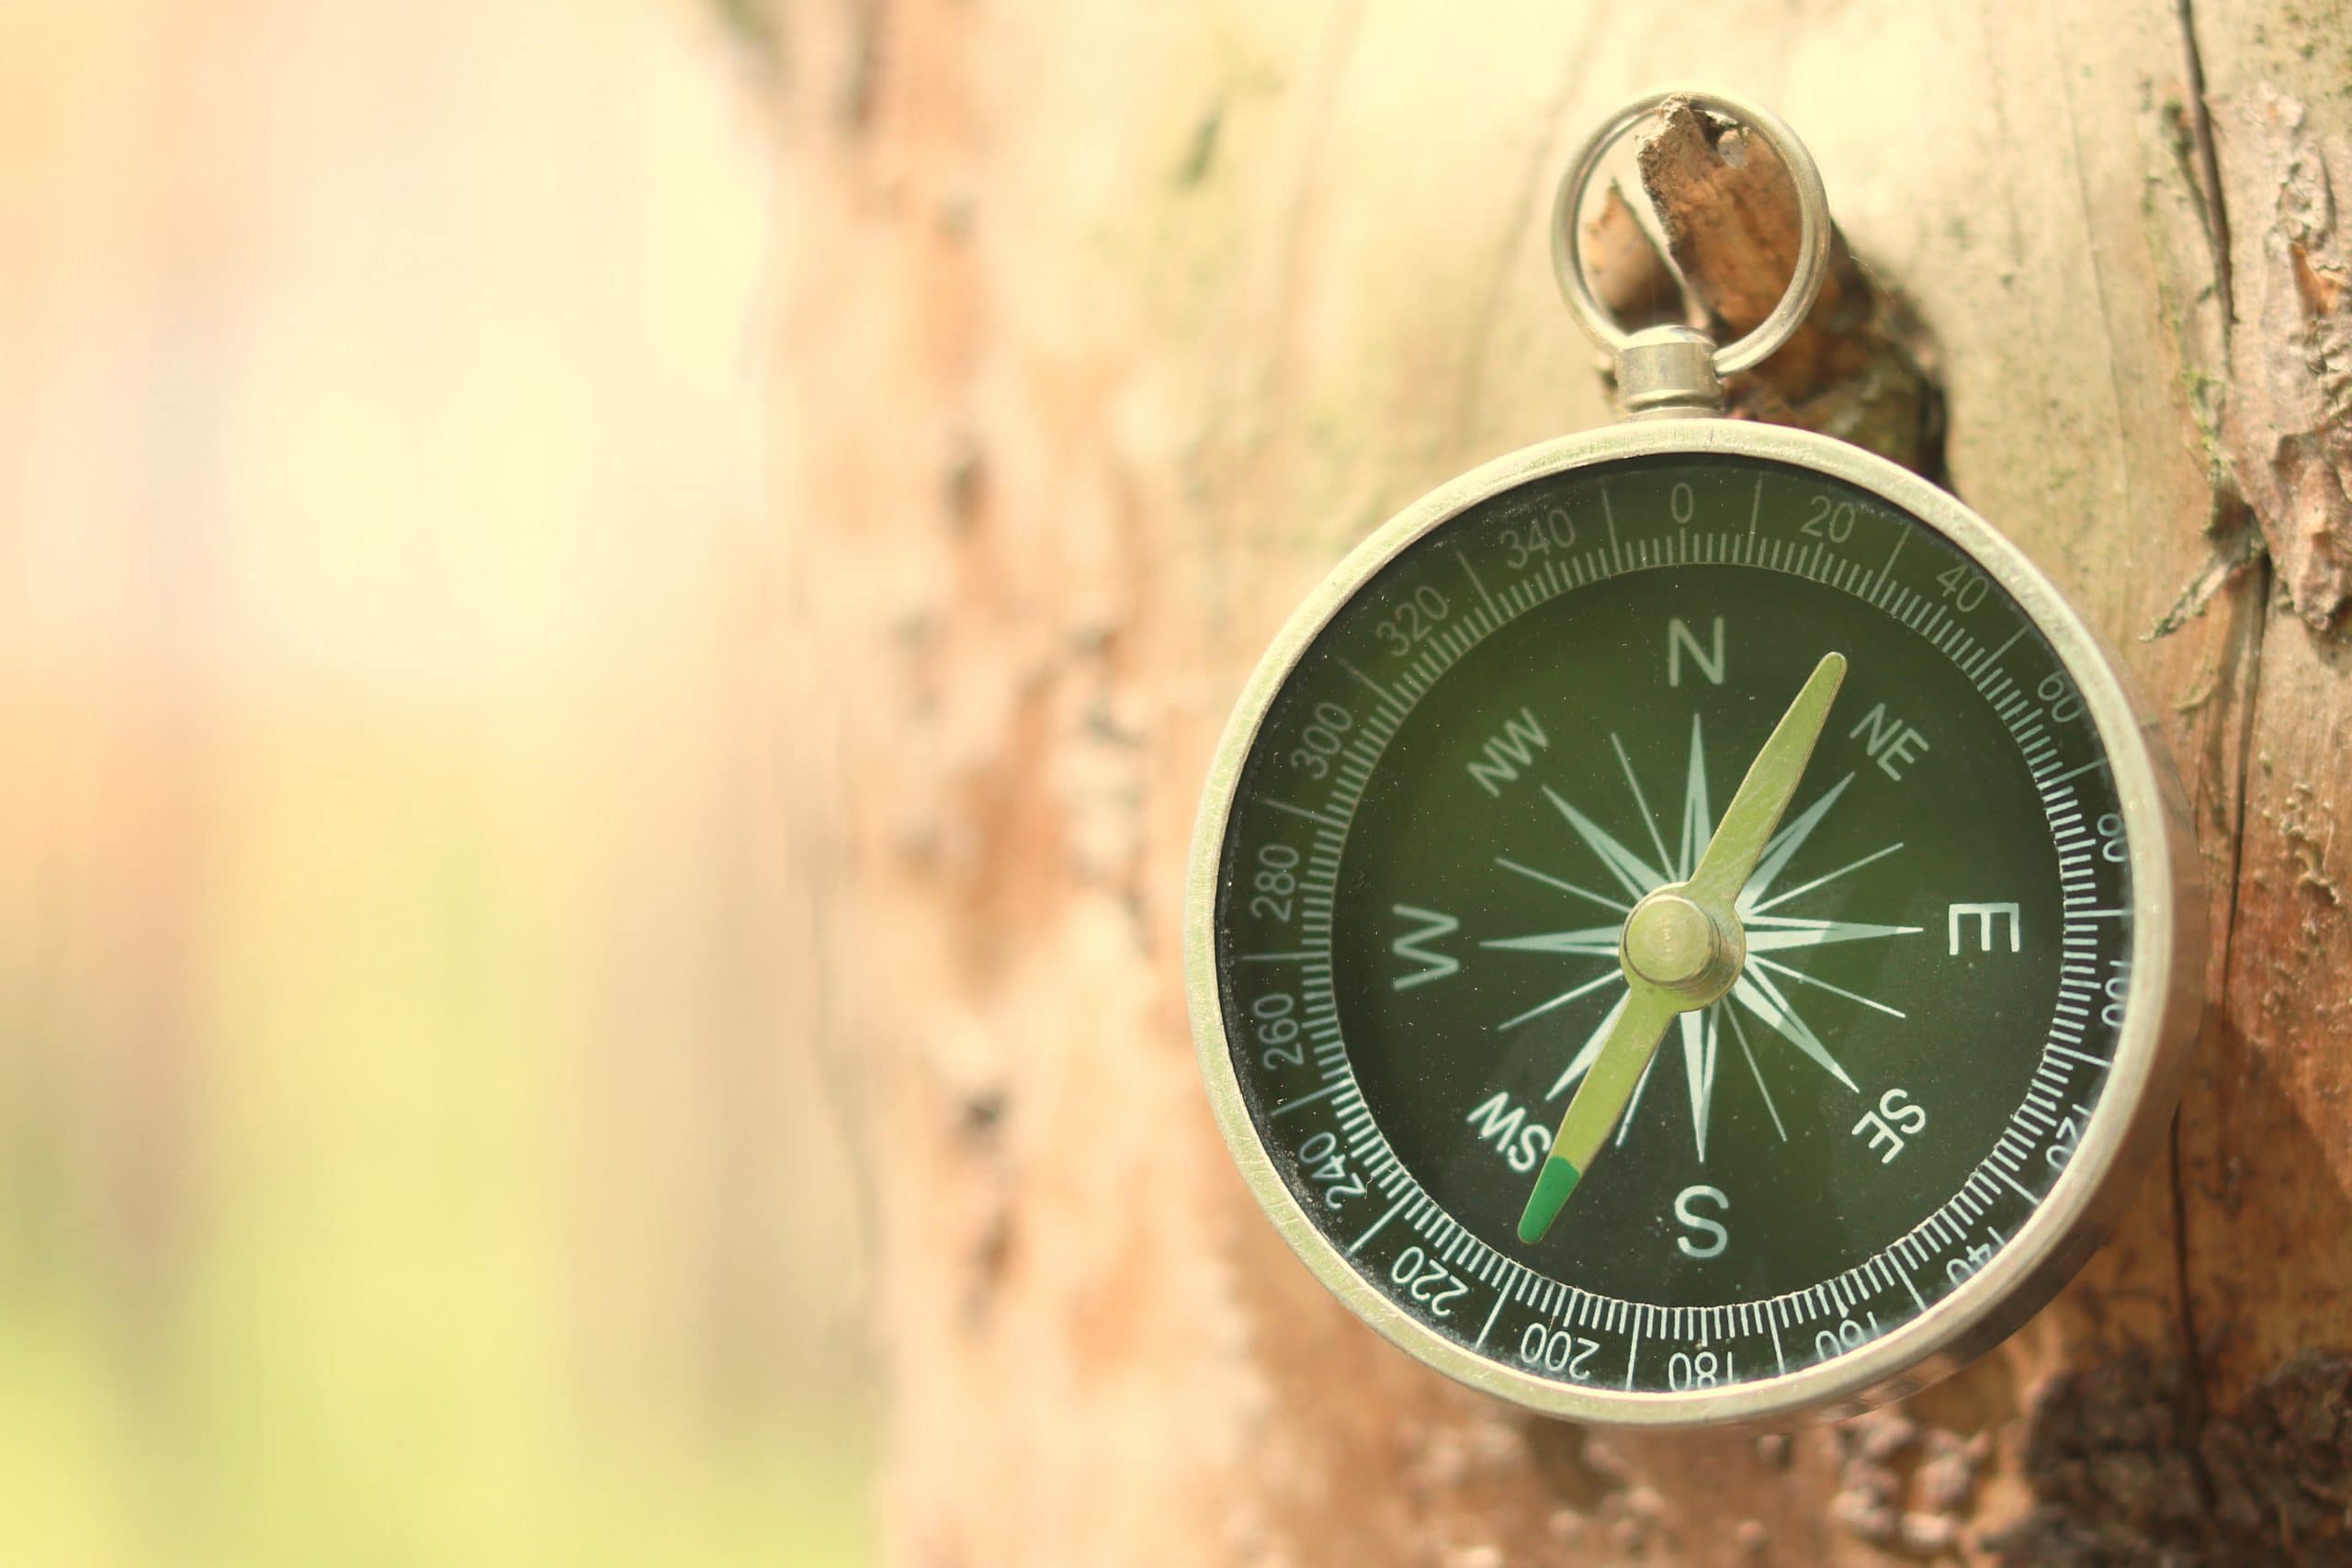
0, 0, 873, 1568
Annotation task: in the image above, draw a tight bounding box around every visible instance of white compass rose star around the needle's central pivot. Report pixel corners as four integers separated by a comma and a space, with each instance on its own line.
1482, 715, 1919, 1159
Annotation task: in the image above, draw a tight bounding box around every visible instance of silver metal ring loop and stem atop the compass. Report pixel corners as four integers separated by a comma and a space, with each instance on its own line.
1553, 87, 1830, 413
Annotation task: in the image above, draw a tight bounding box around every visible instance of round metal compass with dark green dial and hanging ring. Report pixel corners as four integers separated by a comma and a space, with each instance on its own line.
1188, 92, 2201, 1425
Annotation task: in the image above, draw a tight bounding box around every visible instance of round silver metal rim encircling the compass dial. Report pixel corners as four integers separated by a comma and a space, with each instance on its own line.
1185, 419, 2204, 1427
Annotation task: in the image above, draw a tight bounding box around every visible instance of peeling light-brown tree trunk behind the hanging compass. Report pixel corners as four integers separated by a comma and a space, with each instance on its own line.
776, 0, 2352, 1568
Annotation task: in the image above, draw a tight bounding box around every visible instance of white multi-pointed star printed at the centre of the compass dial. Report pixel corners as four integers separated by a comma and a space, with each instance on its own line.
1482, 715, 1922, 1161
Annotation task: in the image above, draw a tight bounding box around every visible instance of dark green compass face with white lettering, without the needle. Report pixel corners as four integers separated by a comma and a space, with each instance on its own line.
1209, 439, 2173, 1396
